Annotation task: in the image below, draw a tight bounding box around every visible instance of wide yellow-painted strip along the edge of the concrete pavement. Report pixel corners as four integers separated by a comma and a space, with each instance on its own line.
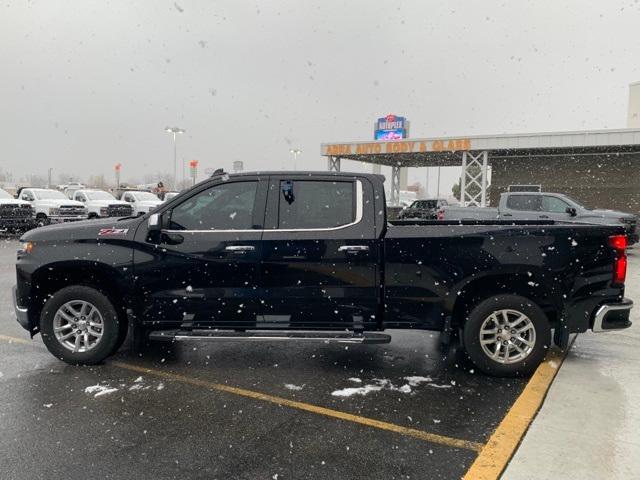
463, 349, 569, 480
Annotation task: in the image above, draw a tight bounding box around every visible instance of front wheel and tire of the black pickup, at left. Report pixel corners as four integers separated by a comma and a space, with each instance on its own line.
40, 285, 122, 365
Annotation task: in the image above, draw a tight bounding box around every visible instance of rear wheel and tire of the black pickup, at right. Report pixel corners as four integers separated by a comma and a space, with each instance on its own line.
463, 295, 551, 377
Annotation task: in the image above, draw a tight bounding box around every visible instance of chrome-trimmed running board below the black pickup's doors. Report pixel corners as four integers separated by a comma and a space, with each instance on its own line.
149, 330, 391, 344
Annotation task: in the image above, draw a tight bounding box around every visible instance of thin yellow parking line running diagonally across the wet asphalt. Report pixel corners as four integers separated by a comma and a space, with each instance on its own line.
0, 335, 483, 452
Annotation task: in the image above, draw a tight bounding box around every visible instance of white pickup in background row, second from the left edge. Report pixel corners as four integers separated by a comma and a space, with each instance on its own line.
18, 188, 89, 226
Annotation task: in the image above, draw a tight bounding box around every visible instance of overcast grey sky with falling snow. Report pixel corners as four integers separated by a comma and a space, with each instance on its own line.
0, 0, 640, 193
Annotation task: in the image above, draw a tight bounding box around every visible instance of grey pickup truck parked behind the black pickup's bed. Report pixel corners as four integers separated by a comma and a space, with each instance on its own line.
438, 192, 638, 244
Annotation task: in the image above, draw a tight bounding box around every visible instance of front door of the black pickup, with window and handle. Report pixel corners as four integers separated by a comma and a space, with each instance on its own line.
134, 176, 267, 328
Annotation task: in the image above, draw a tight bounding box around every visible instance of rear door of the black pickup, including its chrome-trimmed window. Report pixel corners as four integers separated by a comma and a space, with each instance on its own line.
261, 175, 380, 329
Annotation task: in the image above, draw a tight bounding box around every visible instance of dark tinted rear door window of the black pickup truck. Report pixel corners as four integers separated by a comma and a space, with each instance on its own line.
278, 180, 356, 230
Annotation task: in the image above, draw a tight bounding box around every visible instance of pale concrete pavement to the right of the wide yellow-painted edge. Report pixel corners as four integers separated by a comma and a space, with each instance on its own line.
503, 247, 640, 480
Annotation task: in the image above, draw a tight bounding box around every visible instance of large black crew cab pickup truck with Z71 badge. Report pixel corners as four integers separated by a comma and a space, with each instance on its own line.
14, 172, 632, 376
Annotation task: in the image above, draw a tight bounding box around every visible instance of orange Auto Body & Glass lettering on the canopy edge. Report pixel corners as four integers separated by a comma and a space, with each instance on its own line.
322, 138, 471, 156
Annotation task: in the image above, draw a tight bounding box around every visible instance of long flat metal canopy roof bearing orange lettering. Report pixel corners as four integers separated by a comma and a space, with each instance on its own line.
320, 128, 640, 167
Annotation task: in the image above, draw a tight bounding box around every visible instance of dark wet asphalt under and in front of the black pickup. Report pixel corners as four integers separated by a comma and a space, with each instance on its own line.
0, 238, 526, 480
